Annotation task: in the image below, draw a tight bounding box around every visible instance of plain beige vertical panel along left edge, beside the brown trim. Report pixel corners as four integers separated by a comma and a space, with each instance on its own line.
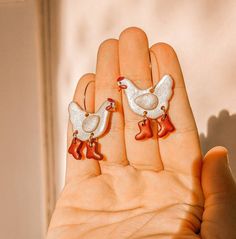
0, 0, 46, 239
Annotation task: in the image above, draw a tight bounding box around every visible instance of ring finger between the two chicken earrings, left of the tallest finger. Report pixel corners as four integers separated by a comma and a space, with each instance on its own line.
95, 39, 128, 169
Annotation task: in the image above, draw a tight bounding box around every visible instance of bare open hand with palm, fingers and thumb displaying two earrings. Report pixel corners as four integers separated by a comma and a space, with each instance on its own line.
47, 27, 236, 239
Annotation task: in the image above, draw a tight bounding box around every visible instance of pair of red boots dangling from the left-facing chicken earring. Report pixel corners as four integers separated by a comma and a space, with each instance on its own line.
135, 114, 175, 140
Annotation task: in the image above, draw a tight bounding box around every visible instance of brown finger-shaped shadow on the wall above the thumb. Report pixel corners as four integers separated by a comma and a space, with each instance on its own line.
200, 110, 236, 178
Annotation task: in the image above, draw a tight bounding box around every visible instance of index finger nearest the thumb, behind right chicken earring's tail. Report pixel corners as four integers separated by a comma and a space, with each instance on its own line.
150, 43, 202, 177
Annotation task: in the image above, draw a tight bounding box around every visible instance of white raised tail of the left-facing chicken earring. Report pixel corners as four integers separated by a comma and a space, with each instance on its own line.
154, 75, 174, 105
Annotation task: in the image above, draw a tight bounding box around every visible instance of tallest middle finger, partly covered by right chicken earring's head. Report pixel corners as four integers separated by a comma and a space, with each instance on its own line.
119, 27, 162, 171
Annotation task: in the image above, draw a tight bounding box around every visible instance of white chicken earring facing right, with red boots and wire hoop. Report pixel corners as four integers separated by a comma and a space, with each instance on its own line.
68, 81, 115, 160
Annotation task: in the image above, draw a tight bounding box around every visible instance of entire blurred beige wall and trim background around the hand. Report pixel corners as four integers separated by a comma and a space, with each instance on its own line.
0, 0, 236, 239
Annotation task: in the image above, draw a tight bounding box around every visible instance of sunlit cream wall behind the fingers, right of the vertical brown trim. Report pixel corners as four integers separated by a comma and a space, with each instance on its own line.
54, 0, 236, 196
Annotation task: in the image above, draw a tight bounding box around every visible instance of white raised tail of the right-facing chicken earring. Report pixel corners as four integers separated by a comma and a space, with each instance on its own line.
69, 102, 85, 130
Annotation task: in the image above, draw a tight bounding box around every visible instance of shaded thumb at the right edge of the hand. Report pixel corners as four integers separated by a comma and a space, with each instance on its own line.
201, 146, 236, 239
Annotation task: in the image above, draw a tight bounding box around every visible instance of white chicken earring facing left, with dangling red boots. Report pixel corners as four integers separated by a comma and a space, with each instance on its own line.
117, 75, 175, 140
